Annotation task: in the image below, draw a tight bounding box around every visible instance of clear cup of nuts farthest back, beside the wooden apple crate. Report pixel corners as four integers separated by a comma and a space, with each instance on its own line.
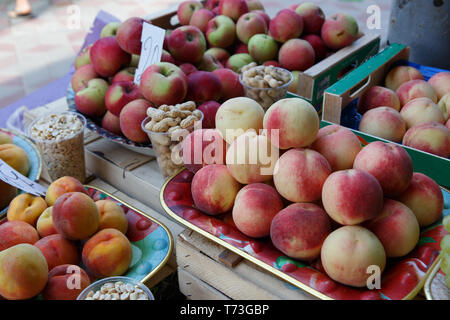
239, 62, 294, 111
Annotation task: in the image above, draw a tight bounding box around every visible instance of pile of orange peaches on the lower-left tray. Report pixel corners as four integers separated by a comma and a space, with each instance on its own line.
0, 177, 132, 300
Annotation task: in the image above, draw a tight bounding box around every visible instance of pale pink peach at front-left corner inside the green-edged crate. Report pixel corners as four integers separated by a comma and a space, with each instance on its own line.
358, 107, 406, 142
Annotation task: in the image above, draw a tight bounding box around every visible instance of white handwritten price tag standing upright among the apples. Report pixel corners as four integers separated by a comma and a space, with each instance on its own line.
134, 22, 166, 85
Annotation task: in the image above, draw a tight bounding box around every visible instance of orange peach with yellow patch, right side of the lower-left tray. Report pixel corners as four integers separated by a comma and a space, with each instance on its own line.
82, 229, 132, 278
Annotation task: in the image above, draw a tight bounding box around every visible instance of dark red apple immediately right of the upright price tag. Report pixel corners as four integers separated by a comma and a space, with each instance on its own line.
169, 26, 206, 63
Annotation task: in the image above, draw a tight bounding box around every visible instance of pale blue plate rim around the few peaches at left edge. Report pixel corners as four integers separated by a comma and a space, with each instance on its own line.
0, 128, 42, 218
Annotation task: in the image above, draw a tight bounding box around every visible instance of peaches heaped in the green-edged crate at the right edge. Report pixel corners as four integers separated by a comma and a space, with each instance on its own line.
357, 66, 450, 158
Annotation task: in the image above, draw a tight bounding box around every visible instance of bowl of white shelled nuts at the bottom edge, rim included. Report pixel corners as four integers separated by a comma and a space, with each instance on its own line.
77, 277, 155, 300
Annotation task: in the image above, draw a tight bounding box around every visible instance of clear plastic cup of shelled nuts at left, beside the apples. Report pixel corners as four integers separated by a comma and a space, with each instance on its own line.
29, 112, 86, 182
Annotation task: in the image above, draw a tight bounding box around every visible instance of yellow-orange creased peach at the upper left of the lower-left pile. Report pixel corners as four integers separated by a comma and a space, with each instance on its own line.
7, 193, 47, 226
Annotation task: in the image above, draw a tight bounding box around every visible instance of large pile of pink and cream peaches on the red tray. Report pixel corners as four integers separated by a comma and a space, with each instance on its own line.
183, 97, 444, 287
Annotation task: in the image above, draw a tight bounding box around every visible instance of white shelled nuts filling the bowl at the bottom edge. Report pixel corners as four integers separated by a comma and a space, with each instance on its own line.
84, 281, 149, 300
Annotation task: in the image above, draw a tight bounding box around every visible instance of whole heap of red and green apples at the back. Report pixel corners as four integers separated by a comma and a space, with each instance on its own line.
71, 0, 358, 143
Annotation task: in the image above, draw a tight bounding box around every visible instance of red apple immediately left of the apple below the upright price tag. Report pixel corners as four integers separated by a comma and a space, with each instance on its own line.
105, 81, 143, 117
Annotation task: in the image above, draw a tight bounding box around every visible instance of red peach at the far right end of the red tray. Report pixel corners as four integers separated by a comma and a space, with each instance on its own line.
397, 172, 444, 227
